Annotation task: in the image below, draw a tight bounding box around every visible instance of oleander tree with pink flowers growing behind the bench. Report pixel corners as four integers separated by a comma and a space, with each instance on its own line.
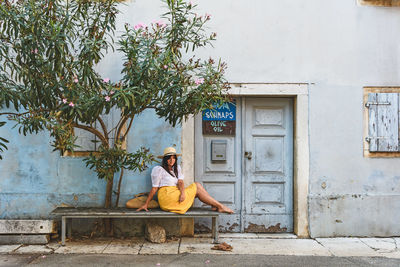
0, 0, 228, 207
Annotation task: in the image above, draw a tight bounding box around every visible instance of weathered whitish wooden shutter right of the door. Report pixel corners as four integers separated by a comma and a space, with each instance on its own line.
365, 93, 399, 152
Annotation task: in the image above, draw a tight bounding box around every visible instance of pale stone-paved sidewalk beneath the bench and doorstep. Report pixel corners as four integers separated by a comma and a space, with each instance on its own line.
0, 237, 400, 258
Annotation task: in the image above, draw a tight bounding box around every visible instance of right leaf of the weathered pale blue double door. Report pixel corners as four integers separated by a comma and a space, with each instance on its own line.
243, 98, 293, 232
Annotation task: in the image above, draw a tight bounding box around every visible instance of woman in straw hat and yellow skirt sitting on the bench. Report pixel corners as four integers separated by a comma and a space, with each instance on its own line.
137, 147, 233, 214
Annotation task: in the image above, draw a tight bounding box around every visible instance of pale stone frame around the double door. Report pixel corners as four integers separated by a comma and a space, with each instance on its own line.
181, 83, 311, 238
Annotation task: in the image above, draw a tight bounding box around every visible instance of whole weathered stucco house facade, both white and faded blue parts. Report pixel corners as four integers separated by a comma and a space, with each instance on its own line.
0, 0, 400, 237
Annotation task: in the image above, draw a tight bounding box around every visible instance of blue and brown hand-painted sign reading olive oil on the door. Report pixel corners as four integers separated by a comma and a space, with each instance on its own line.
202, 102, 236, 135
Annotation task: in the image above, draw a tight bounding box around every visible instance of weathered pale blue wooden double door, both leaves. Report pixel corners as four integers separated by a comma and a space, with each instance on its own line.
195, 98, 293, 232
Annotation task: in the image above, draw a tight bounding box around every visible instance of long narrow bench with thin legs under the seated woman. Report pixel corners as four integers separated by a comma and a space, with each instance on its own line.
51, 207, 220, 246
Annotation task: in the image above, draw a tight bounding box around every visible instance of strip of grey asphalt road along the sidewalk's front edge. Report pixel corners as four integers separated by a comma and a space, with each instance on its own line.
0, 254, 400, 267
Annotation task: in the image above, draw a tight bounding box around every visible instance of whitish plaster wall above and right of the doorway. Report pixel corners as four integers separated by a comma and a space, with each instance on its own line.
111, 0, 400, 237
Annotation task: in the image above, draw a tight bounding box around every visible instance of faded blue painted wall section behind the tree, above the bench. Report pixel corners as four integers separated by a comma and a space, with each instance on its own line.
0, 111, 181, 219
